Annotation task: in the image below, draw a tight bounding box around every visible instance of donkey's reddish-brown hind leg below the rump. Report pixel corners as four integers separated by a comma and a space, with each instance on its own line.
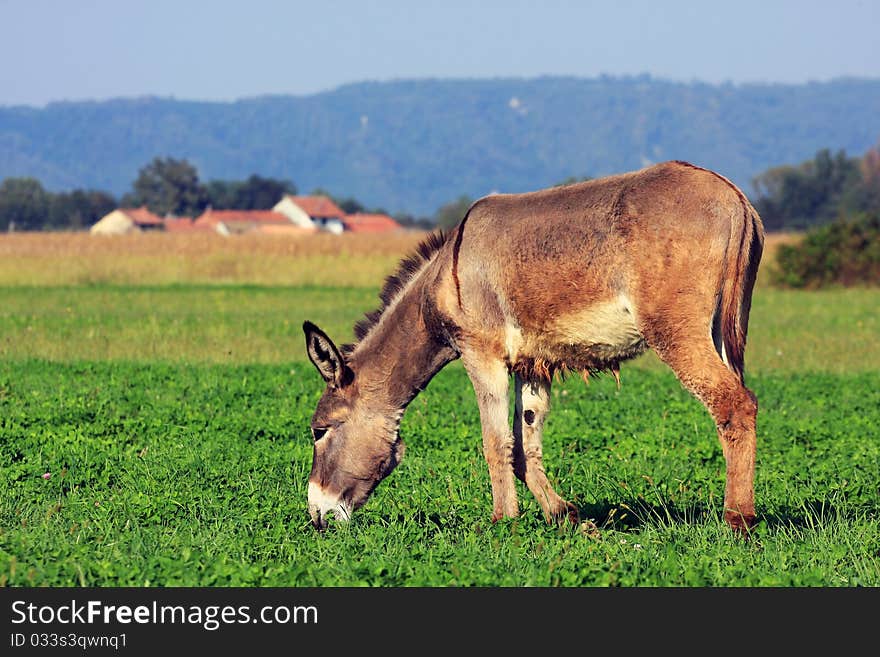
654, 331, 758, 534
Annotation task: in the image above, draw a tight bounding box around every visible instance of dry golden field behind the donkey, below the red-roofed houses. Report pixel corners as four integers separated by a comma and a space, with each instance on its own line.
0, 230, 798, 287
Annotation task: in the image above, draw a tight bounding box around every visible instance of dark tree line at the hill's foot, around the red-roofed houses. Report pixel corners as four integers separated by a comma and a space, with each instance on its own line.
0, 143, 880, 231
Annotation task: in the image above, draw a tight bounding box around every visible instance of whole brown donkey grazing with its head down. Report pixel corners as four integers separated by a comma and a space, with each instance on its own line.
303, 161, 764, 533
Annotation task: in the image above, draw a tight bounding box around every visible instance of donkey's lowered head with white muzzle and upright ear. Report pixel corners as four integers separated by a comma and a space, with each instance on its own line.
303, 322, 404, 529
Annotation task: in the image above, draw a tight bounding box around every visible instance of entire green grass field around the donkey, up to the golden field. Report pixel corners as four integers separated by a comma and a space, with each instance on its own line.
0, 234, 880, 587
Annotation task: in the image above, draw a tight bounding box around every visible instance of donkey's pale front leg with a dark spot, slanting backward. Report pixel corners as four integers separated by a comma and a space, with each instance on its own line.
513, 374, 579, 524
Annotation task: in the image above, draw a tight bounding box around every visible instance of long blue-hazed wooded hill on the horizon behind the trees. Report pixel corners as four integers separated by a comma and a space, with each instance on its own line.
0, 76, 880, 215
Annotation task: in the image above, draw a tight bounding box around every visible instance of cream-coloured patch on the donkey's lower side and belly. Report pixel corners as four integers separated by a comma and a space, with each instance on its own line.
508, 295, 647, 370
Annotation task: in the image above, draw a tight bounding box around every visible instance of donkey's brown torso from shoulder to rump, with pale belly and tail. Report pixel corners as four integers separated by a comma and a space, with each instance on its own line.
451, 162, 763, 374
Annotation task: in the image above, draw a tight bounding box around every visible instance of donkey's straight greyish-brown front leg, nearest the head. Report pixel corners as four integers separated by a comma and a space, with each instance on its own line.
462, 353, 519, 522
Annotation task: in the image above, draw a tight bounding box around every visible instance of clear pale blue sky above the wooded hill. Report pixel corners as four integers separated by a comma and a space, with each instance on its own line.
0, 0, 880, 106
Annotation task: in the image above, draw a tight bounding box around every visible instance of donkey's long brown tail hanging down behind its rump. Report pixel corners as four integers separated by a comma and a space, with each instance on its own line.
719, 197, 764, 382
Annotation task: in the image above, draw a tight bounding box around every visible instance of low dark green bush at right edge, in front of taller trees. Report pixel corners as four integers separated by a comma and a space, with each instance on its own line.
774, 212, 880, 289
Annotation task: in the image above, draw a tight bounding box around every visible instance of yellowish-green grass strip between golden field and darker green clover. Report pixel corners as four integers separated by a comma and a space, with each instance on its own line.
0, 283, 880, 374
